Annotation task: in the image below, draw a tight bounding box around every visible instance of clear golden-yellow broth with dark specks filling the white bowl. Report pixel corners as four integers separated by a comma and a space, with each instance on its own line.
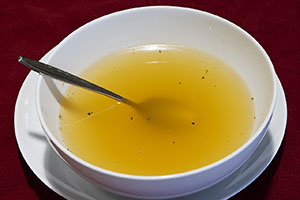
59, 44, 255, 176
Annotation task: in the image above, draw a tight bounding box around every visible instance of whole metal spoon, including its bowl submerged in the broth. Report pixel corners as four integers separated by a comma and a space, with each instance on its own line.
18, 56, 193, 128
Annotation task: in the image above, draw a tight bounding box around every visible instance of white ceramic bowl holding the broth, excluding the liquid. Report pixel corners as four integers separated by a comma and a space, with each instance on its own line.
36, 6, 276, 199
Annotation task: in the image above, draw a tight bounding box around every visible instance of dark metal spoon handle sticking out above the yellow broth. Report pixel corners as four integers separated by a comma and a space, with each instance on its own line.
18, 56, 125, 101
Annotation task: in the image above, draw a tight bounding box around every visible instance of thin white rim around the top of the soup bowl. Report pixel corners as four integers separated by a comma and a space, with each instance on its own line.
35, 6, 277, 181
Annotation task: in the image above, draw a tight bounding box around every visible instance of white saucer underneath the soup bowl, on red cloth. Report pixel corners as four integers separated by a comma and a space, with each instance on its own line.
15, 48, 287, 200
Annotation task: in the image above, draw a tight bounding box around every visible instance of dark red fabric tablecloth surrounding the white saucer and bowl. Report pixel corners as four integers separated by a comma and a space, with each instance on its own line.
0, 0, 300, 199
